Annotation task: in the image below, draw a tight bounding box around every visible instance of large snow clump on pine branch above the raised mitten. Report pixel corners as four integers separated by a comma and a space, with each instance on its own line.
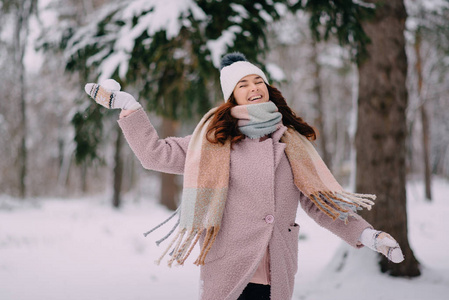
65, 0, 206, 81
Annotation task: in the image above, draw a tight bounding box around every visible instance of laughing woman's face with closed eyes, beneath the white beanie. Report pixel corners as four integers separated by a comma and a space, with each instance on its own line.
233, 75, 270, 105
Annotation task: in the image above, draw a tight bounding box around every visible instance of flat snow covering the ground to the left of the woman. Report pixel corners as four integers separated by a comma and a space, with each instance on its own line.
0, 197, 199, 300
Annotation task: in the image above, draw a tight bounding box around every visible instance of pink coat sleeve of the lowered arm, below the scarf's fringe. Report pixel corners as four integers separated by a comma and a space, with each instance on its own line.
299, 193, 373, 248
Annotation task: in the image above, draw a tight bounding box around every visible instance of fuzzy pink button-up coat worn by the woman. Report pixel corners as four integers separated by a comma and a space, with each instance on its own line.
118, 109, 372, 300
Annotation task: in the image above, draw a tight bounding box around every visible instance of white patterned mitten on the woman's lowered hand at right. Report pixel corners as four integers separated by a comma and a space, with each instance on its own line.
360, 228, 404, 263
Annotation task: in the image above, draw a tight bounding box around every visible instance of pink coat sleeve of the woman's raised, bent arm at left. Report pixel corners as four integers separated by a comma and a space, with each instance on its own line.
118, 108, 190, 174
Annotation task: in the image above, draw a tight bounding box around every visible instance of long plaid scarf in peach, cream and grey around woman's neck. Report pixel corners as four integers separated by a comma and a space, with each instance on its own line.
145, 101, 376, 266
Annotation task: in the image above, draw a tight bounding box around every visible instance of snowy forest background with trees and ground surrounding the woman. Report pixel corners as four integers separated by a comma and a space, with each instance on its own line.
0, 0, 449, 300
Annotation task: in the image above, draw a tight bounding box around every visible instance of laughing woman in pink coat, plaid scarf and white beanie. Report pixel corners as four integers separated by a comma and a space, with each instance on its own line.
85, 53, 403, 300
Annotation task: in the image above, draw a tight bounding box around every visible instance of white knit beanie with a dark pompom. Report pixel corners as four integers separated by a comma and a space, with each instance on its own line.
220, 52, 268, 102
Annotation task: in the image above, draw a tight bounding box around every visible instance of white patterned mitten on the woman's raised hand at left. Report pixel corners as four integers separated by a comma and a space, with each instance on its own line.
84, 79, 142, 110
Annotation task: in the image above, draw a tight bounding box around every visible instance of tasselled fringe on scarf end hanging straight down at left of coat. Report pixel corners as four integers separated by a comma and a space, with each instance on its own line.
155, 226, 220, 267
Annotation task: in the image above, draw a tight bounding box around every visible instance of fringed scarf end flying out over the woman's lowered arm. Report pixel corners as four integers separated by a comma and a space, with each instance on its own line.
309, 191, 376, 224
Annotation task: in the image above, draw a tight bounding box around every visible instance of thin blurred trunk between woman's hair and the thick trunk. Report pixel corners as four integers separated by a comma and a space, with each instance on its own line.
312, 40, 331, 169
